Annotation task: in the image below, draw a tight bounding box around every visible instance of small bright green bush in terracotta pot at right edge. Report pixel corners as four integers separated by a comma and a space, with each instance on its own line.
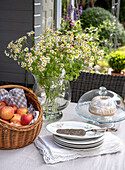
108, 52, 125, 75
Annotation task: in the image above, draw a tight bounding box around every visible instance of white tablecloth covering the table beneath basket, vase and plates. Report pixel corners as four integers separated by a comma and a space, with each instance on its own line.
0, 103, 125, 170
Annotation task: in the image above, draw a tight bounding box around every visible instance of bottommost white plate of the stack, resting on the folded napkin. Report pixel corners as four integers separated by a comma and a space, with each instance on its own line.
54, 141, 103, 151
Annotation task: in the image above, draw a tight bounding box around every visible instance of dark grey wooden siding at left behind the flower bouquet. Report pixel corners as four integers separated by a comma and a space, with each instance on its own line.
0, 0, 34, 84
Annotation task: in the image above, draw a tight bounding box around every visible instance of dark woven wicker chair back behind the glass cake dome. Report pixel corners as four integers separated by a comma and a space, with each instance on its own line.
70, 72, 125, 103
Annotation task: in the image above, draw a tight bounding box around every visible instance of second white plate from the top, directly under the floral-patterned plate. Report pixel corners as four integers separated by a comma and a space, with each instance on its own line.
53, 135, 104, 145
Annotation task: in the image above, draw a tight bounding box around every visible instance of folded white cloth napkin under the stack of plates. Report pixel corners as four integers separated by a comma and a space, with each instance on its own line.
34, 132, 123, 164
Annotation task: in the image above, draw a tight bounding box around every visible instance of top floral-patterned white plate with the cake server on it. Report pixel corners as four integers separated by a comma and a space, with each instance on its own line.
46, 121, 104, 140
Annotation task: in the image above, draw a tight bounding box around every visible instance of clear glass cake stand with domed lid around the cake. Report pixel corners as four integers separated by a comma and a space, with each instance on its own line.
75, 87, 125, 127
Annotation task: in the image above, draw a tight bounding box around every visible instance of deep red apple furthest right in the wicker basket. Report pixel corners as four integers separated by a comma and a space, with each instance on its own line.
21, 113, 33, 125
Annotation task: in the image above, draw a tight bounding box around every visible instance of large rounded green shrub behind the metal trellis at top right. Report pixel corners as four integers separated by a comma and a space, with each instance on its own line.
81, 7, 125, 45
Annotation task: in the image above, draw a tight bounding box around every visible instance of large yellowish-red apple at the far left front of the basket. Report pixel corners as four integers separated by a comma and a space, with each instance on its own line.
0, 106, 14, 120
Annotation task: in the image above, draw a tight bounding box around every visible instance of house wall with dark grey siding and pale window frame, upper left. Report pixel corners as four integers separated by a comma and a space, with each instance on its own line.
0, 0, 62, 84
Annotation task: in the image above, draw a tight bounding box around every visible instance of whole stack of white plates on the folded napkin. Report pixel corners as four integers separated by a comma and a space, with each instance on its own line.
47, 121, 105, 150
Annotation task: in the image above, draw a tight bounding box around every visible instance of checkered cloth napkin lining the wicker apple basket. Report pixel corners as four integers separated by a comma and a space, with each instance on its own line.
0, 88, 39, 124
